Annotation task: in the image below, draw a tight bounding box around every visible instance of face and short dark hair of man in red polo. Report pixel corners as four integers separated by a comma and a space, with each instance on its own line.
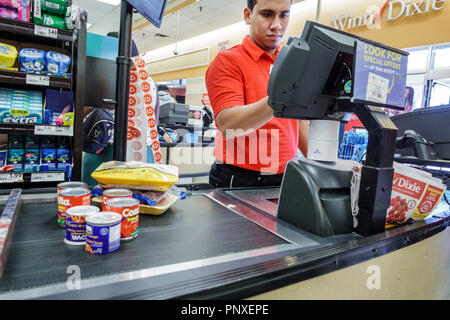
244, 0, 291, 55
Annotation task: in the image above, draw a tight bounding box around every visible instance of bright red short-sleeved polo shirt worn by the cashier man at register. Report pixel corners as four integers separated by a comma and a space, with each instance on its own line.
205, 36, 298, 174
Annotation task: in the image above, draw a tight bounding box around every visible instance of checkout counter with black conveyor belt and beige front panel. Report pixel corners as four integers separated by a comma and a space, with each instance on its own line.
0, 188, 450, 299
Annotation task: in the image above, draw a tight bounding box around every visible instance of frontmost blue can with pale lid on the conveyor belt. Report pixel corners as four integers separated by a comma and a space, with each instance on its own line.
85, 212, 122, 254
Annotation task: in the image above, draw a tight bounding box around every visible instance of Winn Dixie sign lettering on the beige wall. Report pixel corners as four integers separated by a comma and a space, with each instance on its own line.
332, 0, 445, 30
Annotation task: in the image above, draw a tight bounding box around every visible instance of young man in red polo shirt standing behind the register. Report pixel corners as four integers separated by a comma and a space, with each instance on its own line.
206, 0, 308, 187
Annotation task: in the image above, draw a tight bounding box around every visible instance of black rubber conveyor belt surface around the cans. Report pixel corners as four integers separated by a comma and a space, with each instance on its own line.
0, 195, 287, 293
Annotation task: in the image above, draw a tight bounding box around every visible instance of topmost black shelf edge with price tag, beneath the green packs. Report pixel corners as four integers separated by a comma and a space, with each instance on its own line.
0, 18, 74, 42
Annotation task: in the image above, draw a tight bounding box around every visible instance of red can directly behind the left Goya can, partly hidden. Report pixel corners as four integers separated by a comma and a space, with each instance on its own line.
57, 188, 91, 228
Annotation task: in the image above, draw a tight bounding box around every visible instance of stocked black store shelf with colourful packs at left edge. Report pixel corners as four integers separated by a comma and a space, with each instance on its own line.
0, 0, 86, 188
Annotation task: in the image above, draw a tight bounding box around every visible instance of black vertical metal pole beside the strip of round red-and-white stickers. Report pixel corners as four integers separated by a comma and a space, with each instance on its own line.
113, 1, 133, 161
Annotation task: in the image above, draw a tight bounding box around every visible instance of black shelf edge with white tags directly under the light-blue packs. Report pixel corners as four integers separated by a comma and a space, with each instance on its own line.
0, 123, 73, 137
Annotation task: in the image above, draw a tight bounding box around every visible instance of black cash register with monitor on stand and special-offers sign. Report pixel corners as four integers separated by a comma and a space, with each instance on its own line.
268, 21, 408, 237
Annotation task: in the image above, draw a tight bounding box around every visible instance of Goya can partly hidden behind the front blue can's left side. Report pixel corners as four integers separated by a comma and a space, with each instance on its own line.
64, 206, 100, 245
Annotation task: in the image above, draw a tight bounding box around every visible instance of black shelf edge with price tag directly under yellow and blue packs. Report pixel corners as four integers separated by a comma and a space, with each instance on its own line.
0, 70, 72, 89
